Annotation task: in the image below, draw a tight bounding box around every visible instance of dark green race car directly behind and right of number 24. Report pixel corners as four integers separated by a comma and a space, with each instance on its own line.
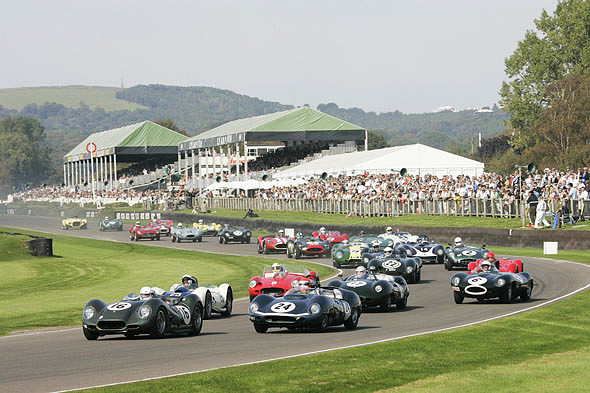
328, 271, 410, 311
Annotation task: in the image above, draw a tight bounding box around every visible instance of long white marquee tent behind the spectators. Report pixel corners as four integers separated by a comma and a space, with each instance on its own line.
273, 144, 484, 179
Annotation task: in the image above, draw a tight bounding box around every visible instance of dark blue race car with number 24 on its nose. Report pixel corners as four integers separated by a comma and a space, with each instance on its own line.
248, 287, 362, 333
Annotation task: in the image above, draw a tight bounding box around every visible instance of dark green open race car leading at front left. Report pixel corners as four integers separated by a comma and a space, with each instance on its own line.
82, 287, 203, 340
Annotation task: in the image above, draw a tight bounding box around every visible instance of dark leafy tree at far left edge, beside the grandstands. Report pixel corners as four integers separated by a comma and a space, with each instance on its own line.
0, 117, 51, 194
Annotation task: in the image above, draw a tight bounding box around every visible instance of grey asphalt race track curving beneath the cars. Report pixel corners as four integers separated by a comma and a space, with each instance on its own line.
0, 216, 590, 392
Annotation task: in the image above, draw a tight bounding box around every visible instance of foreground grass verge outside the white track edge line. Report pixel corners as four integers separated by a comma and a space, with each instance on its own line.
83, 278, 590, 392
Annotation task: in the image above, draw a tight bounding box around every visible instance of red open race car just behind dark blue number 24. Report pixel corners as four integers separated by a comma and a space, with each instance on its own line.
248, 263, 320, 301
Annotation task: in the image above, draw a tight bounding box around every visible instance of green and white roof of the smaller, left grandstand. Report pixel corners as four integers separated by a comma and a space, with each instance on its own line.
64, 120, 187, 162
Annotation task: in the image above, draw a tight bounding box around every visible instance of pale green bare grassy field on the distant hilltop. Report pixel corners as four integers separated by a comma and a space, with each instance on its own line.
0, 86, 145, 112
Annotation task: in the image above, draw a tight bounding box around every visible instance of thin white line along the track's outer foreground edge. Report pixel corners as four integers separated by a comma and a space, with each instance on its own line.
52, 261, 590, 393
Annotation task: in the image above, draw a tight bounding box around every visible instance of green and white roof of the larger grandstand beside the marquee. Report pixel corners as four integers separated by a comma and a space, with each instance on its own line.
178, 107, 365, 150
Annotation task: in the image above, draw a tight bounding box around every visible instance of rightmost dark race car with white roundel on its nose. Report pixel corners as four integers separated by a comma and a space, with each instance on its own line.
451, 269, 533, 304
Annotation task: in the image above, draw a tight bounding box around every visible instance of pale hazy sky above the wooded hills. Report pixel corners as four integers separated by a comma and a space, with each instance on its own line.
0, 0, 558, 113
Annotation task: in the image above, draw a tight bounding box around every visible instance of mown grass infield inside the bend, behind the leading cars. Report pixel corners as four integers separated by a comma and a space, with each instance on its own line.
0, 227, 334, 334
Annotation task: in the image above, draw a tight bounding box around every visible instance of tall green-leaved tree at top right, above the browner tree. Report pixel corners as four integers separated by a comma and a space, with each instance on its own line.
500, 0, 590, 149
